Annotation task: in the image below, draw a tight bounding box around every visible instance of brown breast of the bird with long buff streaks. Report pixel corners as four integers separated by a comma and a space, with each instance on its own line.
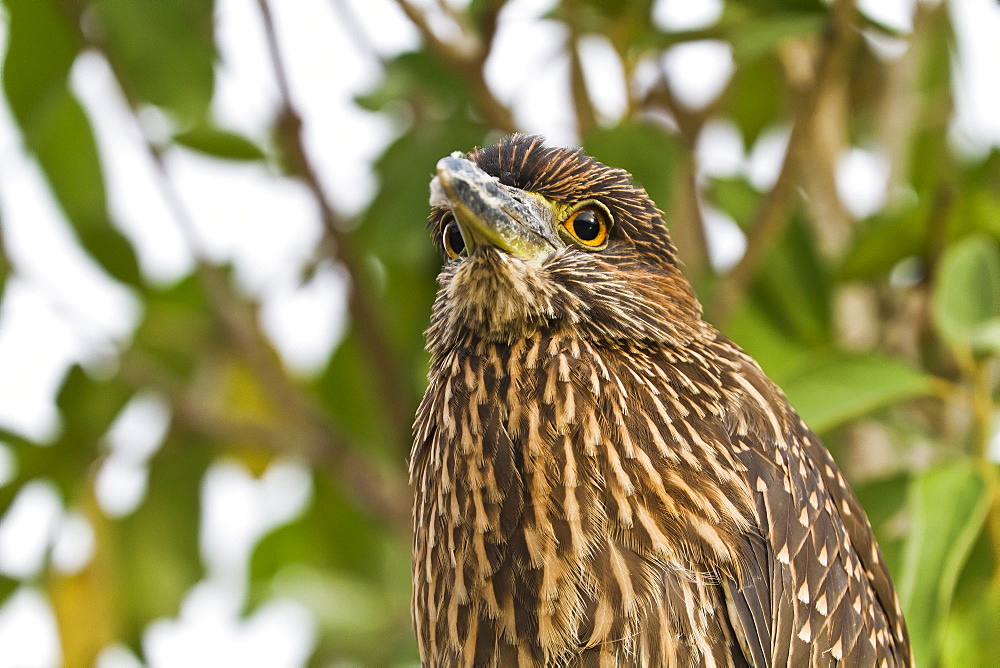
411, 335, 750, 665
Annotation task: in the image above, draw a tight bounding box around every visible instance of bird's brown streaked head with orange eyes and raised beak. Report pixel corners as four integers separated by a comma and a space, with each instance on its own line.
429, 135, 702, 345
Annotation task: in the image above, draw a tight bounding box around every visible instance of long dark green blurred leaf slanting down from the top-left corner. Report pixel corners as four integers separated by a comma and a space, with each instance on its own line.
3, 0, 141, 285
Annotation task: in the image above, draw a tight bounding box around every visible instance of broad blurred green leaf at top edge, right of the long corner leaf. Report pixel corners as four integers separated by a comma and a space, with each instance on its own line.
93, 0, 215, 126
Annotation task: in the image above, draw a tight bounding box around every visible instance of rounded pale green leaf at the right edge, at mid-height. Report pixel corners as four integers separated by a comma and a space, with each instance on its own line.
932, 234, 1000, 347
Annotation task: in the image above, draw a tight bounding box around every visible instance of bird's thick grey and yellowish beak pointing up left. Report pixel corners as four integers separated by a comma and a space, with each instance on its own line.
431, 153, 559, 263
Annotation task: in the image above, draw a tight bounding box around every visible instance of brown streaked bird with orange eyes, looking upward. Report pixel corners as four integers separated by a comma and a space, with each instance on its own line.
409, 134, 913, 667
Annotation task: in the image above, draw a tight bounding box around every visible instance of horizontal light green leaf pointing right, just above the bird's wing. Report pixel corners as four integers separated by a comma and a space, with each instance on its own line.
782, 353, 932, 432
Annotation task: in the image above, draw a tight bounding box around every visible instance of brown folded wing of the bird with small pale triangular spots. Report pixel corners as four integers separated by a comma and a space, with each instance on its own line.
728, 348, 910, 666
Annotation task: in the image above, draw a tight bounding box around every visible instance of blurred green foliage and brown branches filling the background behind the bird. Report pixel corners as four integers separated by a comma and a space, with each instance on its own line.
0, 0, 1000, 666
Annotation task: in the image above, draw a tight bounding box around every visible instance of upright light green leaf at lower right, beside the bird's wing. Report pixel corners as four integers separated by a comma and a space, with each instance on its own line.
899, 459, 994, 666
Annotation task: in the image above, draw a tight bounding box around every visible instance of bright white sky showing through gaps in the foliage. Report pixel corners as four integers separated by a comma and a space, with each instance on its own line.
0, 0, 1000, 668
